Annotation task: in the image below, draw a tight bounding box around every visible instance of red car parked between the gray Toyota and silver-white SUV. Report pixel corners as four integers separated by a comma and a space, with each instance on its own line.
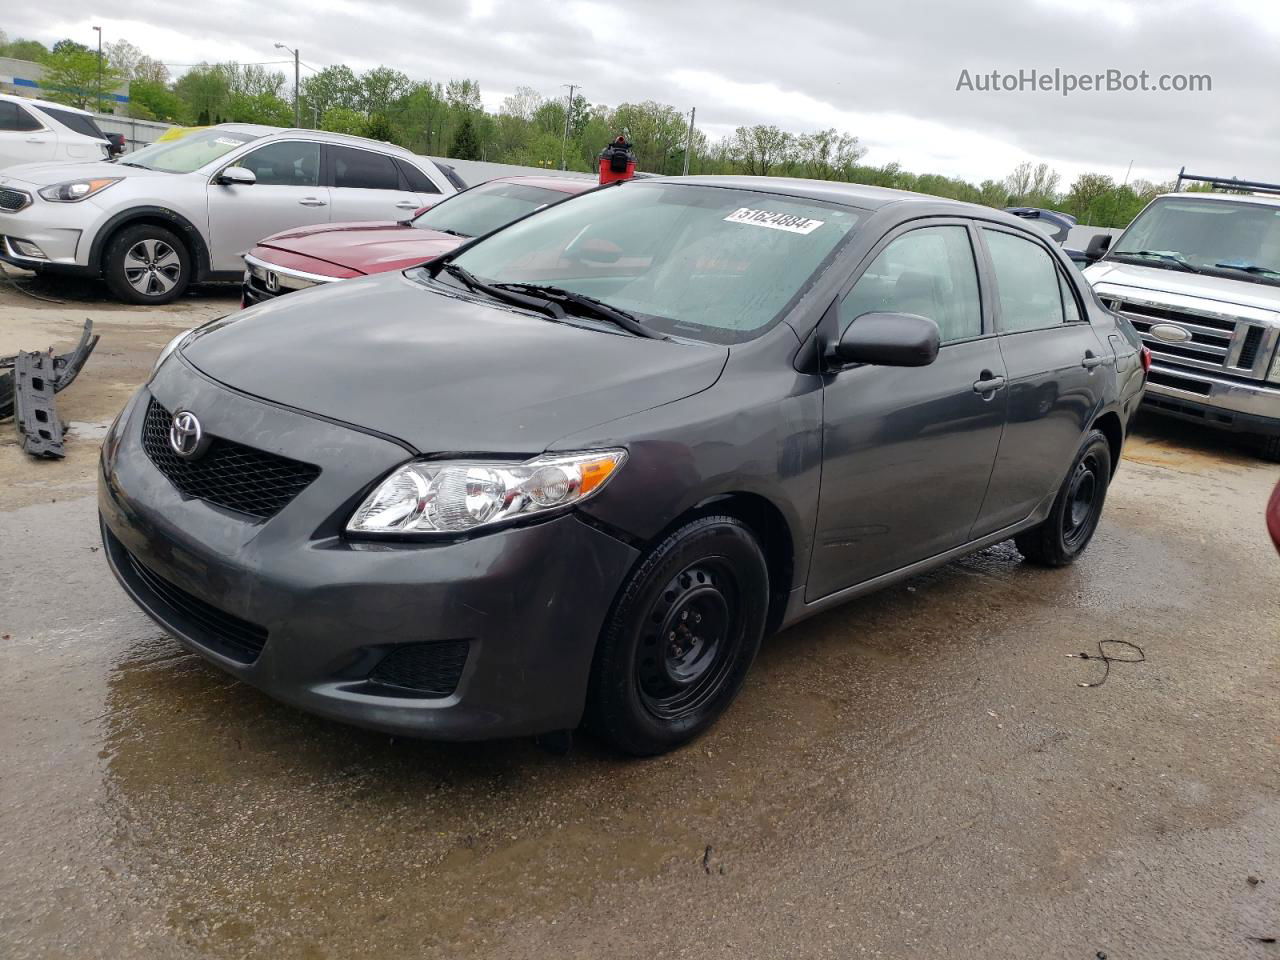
241, 177, 598, 307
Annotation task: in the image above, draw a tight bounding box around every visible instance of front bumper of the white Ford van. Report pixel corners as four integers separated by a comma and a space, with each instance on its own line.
1143, 361, 1280, 435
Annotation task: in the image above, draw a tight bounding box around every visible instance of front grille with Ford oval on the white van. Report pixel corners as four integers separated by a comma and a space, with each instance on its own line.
1110, 300, 1267, 380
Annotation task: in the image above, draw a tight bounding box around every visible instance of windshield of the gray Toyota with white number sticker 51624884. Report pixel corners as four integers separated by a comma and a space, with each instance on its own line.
440, 182, 859, 343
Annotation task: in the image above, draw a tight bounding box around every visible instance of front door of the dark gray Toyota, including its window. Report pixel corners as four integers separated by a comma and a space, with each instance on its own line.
806, 220, 1007, 602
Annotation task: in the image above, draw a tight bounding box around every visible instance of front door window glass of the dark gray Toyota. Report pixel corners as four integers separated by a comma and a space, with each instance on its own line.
840, 227, 982, 343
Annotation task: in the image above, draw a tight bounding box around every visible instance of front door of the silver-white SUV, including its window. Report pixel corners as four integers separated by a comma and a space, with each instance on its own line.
209, 140, 330, 270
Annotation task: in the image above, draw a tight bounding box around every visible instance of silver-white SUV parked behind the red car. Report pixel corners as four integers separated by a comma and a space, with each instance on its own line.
0, 123, 454, 303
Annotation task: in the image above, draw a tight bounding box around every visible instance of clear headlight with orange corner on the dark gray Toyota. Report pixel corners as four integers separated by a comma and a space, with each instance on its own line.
347, 451, 627, 534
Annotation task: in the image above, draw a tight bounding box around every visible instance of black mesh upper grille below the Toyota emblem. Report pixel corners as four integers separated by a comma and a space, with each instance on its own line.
142, 399, 320, 520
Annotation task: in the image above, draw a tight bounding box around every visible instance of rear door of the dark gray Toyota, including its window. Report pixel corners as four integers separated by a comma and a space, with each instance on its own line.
974, 225, 1115, 536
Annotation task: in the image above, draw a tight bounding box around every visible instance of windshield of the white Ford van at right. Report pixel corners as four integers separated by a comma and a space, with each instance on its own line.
1107, 197, 1280, 283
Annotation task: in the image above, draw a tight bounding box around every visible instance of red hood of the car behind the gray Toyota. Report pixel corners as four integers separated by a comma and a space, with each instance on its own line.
259, 221, 466, 274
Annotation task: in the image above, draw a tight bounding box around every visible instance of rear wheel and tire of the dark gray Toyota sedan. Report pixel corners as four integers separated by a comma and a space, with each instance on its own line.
1014, 430, 1111, 567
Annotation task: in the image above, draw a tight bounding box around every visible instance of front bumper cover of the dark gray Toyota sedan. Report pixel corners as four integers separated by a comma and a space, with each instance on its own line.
99, 358, 637, 740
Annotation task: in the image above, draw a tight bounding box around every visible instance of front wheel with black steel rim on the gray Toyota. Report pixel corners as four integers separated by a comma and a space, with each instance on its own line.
585, 516, 769, 756
